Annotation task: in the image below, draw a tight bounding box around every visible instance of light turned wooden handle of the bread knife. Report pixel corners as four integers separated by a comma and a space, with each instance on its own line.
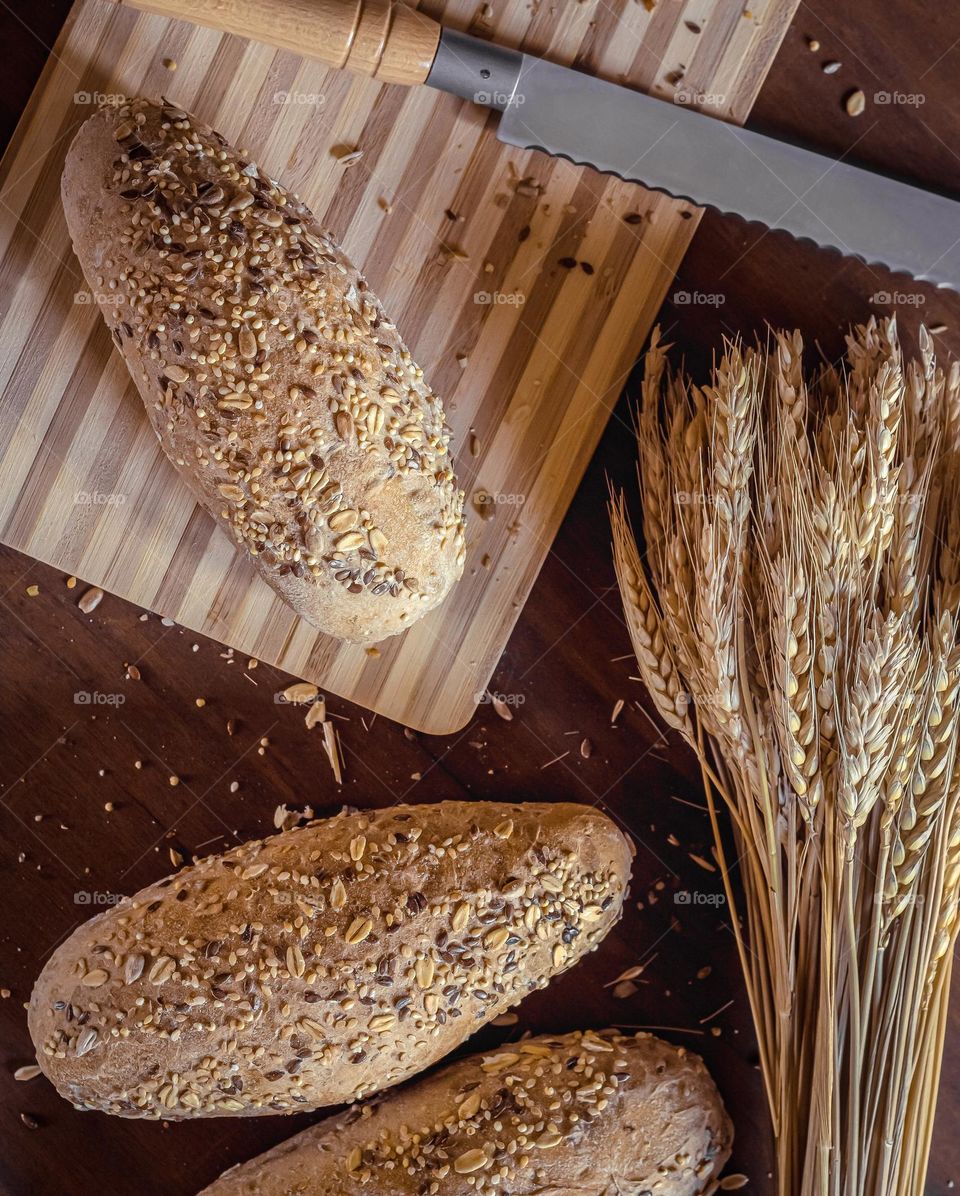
114, 0, 440, 84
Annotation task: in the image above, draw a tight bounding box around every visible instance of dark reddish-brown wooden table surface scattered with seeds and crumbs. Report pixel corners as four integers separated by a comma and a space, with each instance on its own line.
0, 0, 960, 1196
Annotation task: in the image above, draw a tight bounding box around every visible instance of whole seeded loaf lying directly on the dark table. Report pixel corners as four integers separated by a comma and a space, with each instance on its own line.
29, 801, 630, 1119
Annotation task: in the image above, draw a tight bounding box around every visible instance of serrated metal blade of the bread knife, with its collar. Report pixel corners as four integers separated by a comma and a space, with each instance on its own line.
427, 29, 960, 289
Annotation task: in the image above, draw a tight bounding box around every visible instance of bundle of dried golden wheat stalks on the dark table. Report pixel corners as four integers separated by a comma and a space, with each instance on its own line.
611, 319, 960, 1196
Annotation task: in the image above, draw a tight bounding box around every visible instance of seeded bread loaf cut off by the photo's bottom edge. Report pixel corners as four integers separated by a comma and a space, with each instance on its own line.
201, 1031, 733, 1196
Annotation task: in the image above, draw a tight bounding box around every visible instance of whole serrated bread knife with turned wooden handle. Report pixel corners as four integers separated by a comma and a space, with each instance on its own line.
105, 0, 960, 289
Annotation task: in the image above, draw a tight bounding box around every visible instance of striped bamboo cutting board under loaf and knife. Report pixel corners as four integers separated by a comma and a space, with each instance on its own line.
0, 0, 799, 733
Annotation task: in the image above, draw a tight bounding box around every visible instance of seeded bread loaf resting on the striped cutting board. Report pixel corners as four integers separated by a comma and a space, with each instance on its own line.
62, 99, 464, 641
